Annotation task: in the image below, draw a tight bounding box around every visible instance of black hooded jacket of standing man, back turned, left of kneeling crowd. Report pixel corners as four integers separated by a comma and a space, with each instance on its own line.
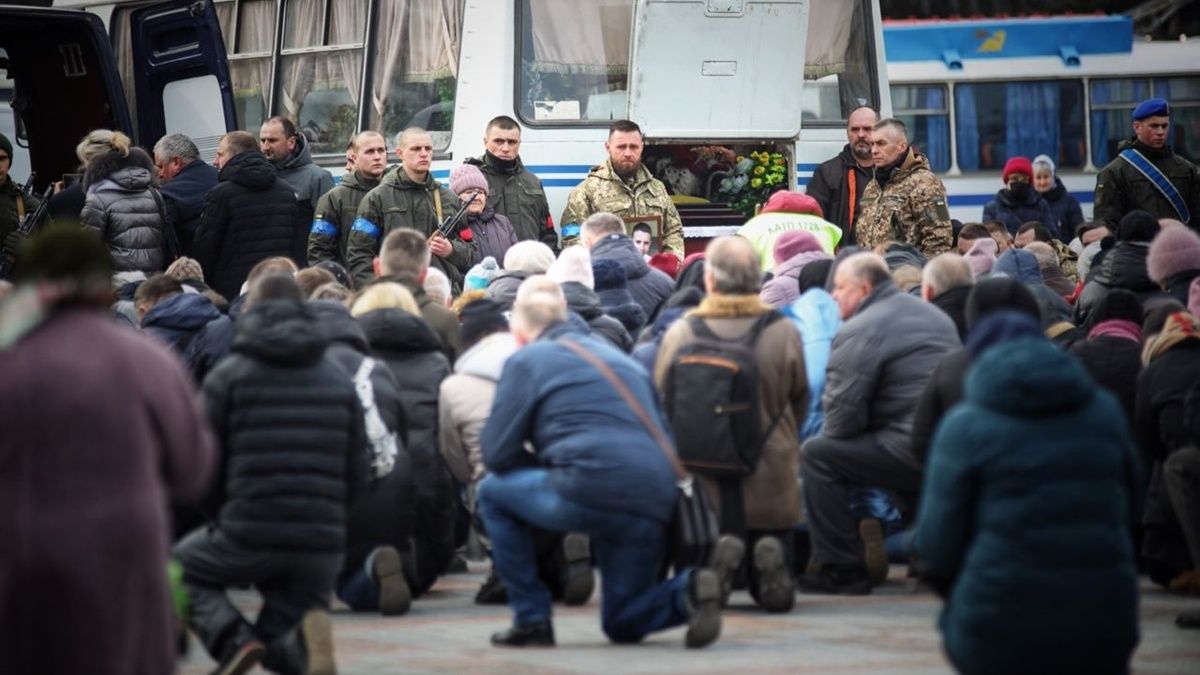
192, 150, 310, 300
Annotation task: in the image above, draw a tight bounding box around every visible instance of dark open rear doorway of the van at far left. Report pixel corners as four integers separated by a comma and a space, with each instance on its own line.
0, 6, 131, 191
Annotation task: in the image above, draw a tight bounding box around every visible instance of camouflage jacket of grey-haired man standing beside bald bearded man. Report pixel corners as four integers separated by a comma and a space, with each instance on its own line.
854, 149, 953, 257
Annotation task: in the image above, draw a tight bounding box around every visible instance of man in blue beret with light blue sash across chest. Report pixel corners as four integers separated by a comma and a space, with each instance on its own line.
1093, 98, 1200, 231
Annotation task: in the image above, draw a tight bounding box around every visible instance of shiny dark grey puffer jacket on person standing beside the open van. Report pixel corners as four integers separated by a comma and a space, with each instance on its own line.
79, 148, 167, 275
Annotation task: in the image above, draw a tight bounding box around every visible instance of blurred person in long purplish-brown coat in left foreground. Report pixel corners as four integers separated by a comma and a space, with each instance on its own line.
0, 227, 214, 675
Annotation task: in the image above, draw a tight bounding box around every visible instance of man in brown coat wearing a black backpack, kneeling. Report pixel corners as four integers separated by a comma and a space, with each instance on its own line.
654, 237, 808, 611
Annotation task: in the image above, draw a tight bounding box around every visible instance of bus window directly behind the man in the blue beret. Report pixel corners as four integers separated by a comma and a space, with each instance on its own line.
1090, 77, 1200, 167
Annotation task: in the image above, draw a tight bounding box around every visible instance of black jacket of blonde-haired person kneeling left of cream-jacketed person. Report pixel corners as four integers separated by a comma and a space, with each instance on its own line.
358, 309, 456, 593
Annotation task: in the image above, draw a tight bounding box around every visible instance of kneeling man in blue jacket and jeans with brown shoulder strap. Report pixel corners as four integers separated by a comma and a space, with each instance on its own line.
479, 276, 721, 647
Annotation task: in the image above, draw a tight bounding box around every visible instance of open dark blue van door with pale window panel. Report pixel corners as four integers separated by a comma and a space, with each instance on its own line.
130, 0, 238, 159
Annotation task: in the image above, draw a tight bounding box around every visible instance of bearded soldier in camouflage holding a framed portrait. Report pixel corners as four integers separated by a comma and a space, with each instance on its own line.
558, 120, 683, 261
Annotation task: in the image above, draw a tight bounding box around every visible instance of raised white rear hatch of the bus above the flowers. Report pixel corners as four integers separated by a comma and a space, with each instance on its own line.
629, 0, 809, 139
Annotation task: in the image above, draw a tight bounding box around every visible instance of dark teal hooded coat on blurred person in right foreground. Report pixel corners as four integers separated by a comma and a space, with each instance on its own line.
913, 339, 1140, 674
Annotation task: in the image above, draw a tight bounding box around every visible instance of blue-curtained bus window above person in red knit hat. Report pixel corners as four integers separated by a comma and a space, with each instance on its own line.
954, 80, 1085, 172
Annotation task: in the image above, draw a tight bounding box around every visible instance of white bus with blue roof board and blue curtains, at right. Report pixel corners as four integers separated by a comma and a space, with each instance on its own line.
883, 17, 1200, 221
